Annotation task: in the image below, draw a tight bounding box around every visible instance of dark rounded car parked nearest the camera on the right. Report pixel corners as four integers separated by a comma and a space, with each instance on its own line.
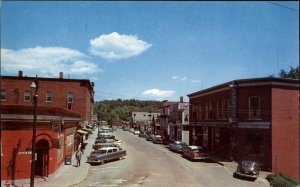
234, 160, 260, 180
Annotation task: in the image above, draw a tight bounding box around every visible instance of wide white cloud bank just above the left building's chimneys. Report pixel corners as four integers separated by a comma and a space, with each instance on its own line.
1, 46, 100, 77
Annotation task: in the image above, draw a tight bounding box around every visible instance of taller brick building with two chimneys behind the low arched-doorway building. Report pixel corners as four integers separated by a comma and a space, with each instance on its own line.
1, 71, 94, 121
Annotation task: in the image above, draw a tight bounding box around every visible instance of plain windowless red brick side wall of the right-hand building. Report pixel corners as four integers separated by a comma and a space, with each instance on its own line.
272, 88, 300, 179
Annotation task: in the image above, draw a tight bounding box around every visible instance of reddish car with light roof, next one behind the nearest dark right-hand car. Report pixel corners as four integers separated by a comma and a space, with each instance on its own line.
182, 145, 208, 160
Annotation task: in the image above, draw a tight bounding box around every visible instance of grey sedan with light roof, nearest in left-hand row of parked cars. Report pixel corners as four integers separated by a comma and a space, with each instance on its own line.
87, 147, 126, 164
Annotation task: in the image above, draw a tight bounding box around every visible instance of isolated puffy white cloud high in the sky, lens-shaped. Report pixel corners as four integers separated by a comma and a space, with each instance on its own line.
90, 32, 152, 60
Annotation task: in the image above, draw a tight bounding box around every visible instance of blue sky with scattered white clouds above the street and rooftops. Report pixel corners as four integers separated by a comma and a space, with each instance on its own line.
1, 1, 299, 101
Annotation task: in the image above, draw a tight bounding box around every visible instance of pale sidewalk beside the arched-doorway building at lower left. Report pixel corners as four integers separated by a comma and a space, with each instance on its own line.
22, 131, 97, 187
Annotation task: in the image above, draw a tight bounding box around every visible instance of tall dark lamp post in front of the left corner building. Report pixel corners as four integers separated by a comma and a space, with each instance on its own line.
30, 80, 39, 187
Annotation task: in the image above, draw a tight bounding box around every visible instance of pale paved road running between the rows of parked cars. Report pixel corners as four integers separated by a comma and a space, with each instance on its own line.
76, 130, 269, 187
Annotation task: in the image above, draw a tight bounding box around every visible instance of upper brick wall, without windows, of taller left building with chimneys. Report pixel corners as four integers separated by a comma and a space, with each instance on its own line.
1, 78, 92, 120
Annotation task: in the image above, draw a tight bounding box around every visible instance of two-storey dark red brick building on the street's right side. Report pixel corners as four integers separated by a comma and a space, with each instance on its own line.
188, 78, 300, 179
